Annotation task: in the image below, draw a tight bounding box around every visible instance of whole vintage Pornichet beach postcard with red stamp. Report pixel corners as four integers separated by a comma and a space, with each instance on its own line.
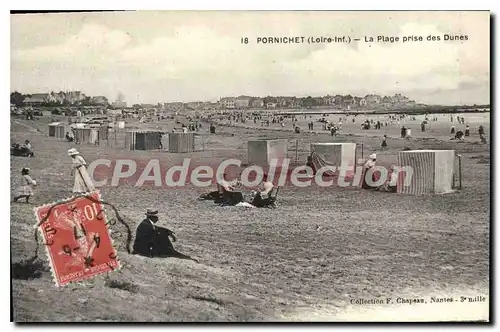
10, 11, 493, 323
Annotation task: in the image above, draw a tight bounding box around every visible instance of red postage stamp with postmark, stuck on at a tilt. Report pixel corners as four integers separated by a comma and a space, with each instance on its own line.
35, 192, 120, 286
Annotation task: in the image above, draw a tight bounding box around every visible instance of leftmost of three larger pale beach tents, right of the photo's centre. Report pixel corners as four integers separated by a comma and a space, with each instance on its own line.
248, 139, 288, 166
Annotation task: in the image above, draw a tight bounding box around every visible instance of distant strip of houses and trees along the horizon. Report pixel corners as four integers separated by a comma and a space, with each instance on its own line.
10, 91, 488, 114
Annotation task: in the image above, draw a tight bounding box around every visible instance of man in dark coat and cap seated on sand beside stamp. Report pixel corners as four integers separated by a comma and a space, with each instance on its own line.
133, 209, 198, 263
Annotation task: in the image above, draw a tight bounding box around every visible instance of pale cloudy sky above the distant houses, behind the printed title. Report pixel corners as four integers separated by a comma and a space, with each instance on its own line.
11, 11, 490, 105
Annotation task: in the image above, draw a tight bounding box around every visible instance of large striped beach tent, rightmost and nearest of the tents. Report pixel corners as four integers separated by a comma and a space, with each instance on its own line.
397, 150, 455, 195
